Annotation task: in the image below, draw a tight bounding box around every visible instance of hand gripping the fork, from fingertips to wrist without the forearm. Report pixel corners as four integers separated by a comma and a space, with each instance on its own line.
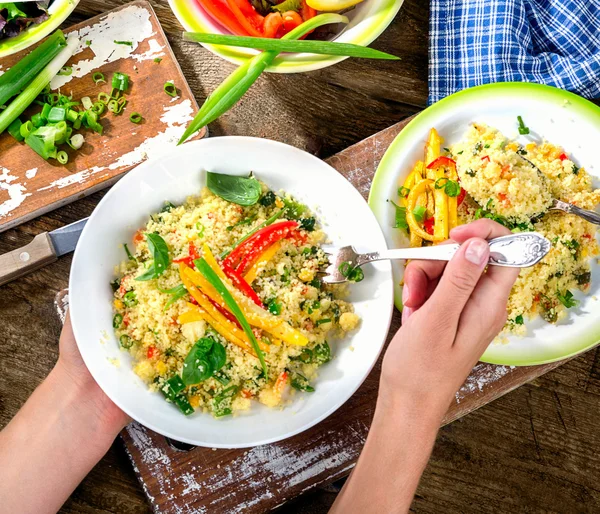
381, 219, 519, 416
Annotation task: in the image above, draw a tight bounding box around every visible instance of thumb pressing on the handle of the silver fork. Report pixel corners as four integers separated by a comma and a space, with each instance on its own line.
424, 237, 490, 331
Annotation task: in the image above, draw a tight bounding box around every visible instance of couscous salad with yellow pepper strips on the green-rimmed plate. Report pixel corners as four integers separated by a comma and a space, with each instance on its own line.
392, 119, 600, 335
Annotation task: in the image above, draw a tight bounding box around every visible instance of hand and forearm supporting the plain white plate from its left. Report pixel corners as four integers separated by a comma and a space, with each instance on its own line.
0, 310, 129, 514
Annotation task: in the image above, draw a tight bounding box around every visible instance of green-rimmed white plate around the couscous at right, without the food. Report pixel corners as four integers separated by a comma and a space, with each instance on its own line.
369, 82, 600, 366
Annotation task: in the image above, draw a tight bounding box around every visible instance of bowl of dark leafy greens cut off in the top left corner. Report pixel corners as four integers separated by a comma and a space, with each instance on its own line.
0, 0, 79, 59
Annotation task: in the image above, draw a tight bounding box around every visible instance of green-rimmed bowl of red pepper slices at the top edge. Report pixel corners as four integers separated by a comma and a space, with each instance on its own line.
169, 0, 404, 73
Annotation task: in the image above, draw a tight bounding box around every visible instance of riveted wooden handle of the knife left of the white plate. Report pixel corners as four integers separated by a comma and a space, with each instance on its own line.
0, 232, 58, 286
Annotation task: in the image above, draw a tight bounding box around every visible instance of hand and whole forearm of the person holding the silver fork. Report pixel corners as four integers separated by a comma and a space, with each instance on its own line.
332, 219, 519, 514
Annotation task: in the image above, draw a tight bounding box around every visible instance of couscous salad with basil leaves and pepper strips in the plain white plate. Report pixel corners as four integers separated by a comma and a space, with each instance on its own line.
112, 173, 360, 417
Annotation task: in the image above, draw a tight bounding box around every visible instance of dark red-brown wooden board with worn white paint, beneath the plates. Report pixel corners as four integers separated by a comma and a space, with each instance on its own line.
57, 119, 566, 514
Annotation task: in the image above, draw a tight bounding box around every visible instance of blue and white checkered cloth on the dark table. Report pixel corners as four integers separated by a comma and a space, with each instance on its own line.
429, 0, 600, 104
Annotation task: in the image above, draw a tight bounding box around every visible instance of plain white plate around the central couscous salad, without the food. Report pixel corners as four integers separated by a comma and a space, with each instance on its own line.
69, 137, 393, 448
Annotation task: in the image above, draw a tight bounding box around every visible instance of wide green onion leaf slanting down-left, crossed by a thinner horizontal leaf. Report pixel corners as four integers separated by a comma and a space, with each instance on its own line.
178, 13, 349, 144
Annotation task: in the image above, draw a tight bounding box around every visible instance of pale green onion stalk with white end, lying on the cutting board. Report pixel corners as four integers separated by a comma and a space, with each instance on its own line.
0, 37, 79, 134
